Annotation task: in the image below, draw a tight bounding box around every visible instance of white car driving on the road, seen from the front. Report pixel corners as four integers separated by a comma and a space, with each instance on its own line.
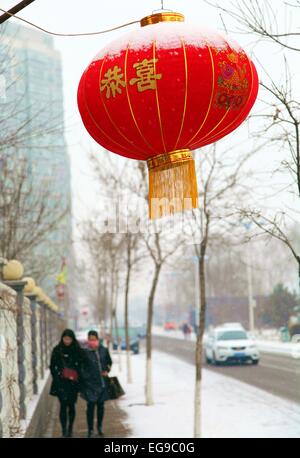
205, 326, 260, 365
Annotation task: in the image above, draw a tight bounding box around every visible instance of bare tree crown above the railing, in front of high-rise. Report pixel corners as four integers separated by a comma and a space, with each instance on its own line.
0, 155, 70, 261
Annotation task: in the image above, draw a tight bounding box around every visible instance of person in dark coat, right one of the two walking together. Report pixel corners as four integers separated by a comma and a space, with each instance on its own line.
81, 331, 112, 437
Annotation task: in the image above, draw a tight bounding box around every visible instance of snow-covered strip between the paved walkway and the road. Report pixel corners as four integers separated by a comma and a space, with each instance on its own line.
110, 352, 300, 438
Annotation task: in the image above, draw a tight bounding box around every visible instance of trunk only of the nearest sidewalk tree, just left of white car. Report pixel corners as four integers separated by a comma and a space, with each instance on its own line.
194, 240, 207, 438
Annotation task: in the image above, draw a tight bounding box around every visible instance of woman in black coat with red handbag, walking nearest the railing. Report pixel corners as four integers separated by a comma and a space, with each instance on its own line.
50, 329, 84, 437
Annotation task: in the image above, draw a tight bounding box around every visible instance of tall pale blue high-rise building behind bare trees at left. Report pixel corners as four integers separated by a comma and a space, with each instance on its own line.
0, 21, 72, 300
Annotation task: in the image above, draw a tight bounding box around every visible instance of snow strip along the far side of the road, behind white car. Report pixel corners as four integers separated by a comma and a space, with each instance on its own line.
153, 326, 300, 359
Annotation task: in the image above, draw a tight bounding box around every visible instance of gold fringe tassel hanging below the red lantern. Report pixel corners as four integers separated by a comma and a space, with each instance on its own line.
147, 149, 198, 219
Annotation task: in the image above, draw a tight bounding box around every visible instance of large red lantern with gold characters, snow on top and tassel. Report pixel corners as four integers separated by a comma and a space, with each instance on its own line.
78, 13, 258, 218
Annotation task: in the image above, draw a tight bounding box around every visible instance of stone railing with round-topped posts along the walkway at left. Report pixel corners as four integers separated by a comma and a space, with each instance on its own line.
0, 279, 63, 438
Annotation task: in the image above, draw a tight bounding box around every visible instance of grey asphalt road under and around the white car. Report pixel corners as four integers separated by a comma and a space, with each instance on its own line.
153, 336, 300, 404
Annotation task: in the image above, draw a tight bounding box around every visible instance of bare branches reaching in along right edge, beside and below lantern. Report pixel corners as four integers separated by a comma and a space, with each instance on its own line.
207, 0, 300, 296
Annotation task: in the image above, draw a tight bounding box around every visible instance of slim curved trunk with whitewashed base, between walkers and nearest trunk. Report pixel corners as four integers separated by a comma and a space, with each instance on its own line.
145, 264, 161, 406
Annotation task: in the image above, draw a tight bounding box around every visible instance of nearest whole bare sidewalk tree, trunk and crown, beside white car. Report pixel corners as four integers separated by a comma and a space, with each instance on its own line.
189, 146, 254, 438
